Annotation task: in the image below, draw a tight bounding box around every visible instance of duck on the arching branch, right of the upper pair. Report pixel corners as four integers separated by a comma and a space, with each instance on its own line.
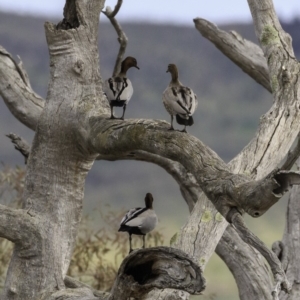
163, 64, 198, 132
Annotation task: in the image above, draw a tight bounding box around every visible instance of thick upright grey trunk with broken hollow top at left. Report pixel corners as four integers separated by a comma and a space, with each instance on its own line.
4, 1, 106, 300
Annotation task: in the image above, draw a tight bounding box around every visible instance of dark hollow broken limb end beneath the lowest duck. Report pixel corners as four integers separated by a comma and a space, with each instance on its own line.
111, 247, 205, 299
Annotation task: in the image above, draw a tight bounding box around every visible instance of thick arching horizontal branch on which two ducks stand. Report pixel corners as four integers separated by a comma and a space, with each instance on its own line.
90, 118, 300, 217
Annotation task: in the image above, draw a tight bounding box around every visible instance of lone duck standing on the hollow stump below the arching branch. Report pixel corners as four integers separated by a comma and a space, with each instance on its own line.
118, 193, 157, 253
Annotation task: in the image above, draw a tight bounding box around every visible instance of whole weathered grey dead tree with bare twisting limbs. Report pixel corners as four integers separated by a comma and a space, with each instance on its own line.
0, 0, 300, 300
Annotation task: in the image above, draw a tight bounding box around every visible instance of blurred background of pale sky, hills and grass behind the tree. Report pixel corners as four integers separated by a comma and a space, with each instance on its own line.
0, 0, 300, 300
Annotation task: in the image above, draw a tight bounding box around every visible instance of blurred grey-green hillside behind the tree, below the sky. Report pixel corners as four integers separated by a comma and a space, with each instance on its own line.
0, 13, 300, 300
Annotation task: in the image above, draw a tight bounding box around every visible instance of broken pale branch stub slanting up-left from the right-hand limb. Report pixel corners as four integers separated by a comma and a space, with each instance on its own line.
194, 18, 272, 92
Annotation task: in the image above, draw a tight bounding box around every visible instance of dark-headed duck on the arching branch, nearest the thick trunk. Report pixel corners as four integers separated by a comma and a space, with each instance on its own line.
103, 56, 140, 120
